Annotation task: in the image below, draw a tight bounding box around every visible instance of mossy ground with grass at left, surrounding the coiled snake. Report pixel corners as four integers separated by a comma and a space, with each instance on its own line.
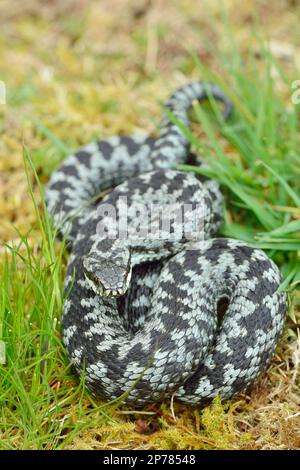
0, 0, 300, 449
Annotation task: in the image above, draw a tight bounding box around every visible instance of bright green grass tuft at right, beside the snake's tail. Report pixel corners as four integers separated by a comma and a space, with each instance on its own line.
177, 45, 300, 298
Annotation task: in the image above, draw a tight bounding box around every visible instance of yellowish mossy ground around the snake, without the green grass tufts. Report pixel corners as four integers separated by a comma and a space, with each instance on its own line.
0, 0, 300, 449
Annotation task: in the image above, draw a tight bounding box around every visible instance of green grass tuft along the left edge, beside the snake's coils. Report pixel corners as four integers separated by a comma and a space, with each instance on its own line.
0, 150, 113, 449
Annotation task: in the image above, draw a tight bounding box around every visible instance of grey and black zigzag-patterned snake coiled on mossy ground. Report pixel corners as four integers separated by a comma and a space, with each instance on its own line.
46, 82, 287, 406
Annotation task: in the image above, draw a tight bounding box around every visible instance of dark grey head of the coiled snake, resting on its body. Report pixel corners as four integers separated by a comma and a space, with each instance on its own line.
83, 248, 132, 297
